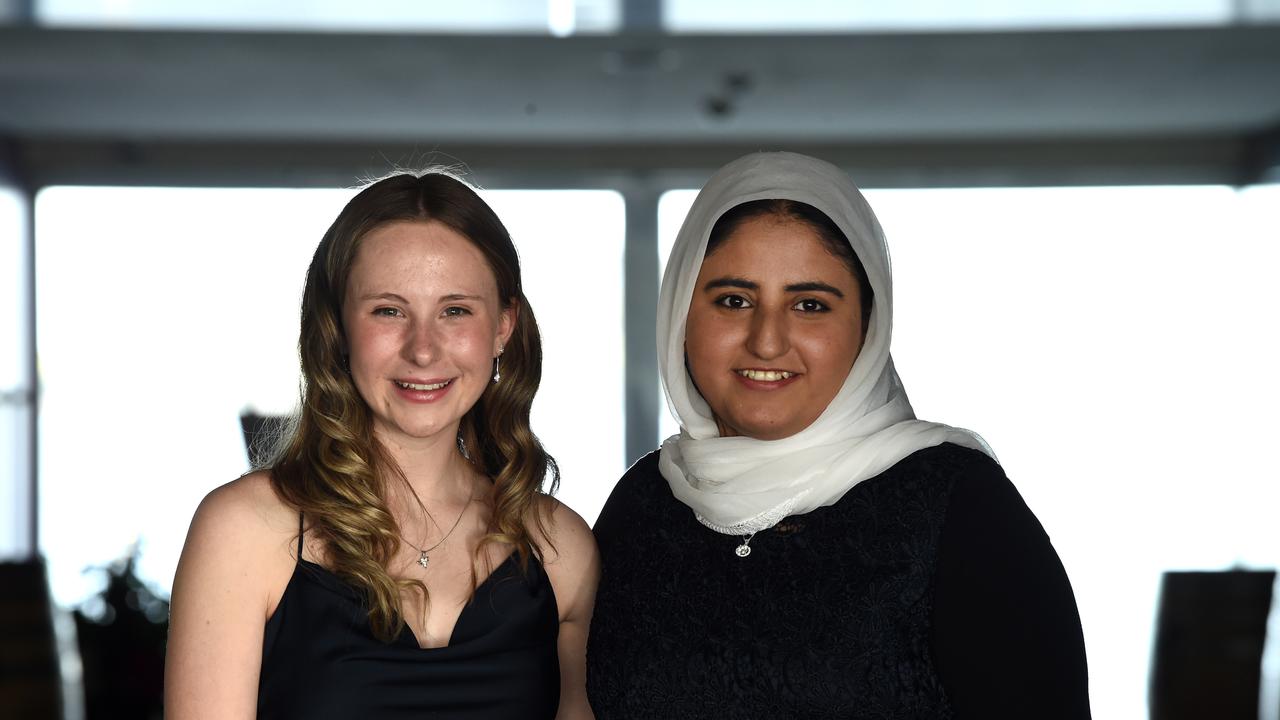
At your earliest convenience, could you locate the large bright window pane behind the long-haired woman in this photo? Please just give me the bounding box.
[36,181,623,605]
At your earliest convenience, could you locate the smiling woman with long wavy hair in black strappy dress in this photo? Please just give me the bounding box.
[165,173,598,720]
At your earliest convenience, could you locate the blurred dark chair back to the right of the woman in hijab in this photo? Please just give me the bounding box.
[1151,570,1276,720]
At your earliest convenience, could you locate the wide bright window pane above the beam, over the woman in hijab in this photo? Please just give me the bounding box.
[663,0,1236,32]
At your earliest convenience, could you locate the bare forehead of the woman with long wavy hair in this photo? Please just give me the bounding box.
[348,220,497,295]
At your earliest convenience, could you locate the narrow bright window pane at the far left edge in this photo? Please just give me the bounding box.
[0,187,33,560]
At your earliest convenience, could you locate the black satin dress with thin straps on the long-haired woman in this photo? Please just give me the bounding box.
[257,515,559,720]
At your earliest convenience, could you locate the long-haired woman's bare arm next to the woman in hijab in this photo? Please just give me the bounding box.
[543,501,600,720]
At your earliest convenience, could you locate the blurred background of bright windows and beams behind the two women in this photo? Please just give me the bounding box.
[0,0,1280,720]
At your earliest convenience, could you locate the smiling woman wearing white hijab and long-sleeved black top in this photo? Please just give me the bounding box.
[588,152,1089,720]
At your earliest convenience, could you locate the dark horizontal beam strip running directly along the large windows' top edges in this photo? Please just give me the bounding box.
[7,136,1249,188]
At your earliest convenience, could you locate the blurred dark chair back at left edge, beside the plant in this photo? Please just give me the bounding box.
[0,560,63,720]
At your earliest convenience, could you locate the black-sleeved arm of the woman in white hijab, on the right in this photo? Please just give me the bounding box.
[933,461,1089,720]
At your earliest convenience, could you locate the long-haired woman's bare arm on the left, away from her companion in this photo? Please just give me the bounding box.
[164,473,297,720]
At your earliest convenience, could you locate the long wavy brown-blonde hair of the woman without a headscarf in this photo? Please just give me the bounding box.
[266,172,559,642]
